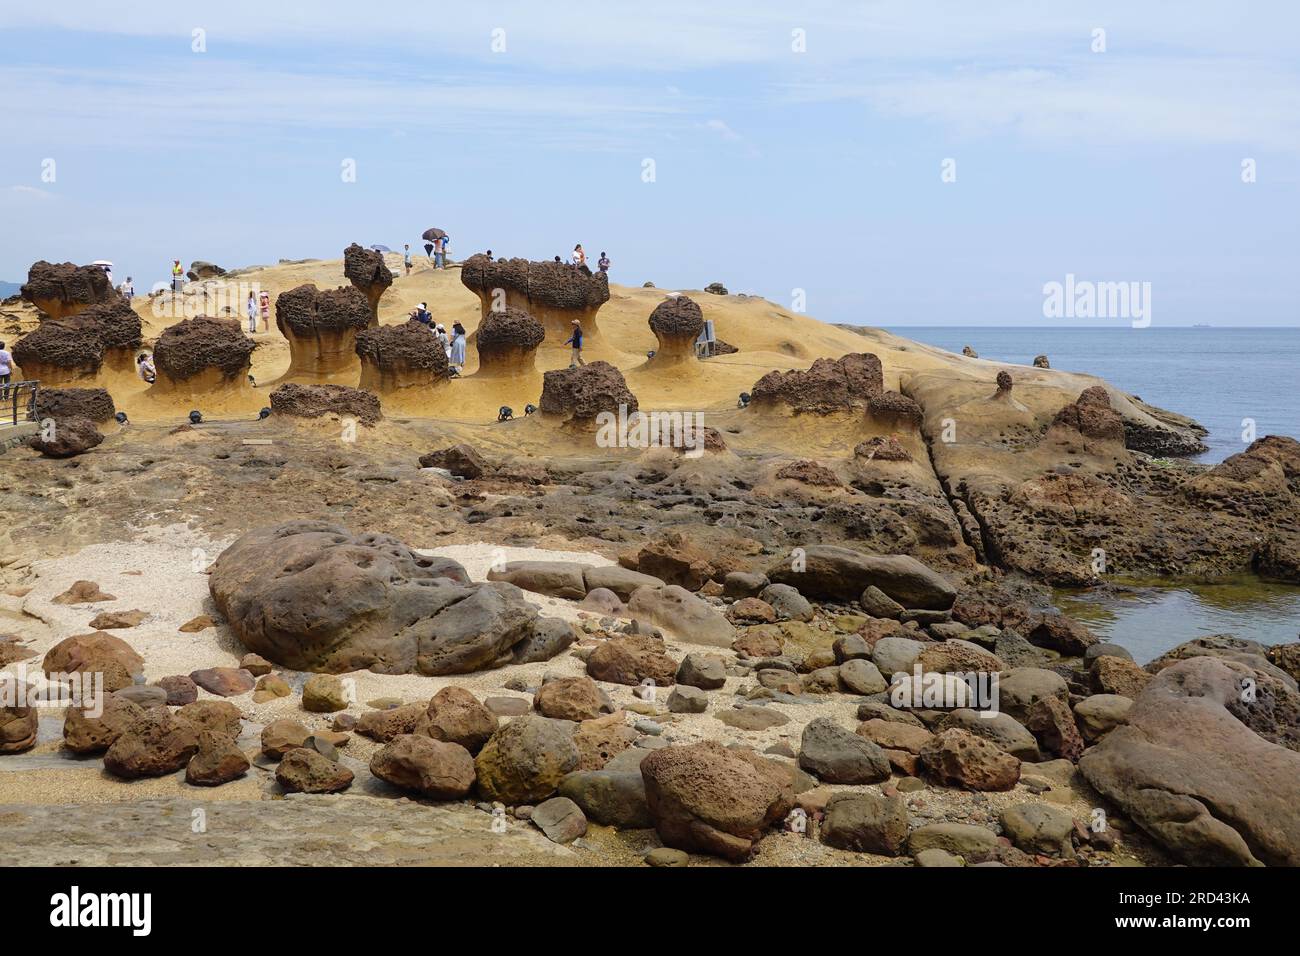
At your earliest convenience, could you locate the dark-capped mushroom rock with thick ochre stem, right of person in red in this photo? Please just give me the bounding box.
[276,284,371,382]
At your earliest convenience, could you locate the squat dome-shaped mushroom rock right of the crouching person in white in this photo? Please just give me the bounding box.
[150,316,255,395]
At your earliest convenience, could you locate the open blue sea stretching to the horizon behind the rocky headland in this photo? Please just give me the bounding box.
[889,325,1300,462]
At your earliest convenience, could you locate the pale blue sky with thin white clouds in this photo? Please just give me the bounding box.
[0,0,1300,328]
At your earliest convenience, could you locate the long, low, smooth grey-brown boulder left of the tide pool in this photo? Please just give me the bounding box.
[767,545,957,610]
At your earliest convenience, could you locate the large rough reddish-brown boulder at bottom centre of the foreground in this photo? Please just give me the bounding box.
[641,741,794,861]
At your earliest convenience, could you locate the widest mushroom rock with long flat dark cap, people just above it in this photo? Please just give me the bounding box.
[460,254,610,347]
